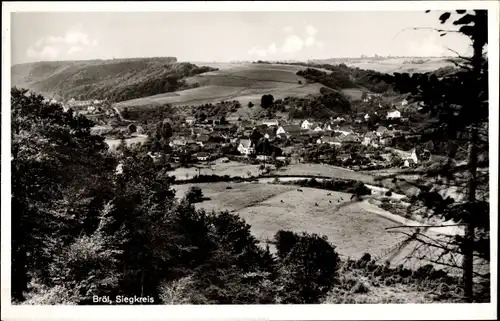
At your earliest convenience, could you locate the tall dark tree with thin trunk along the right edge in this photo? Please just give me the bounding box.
[374,10,489,302]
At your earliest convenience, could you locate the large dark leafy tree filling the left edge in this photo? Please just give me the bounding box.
[11,88,116,302]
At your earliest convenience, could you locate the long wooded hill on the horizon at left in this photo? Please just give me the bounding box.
[11,57,216,101]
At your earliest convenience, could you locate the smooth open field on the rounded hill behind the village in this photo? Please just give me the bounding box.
[115,64,322,107]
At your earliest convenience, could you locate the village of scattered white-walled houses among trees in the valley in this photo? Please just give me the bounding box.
[52,94,442,174]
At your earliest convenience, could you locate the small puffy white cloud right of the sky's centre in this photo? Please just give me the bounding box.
[248,25,325,57]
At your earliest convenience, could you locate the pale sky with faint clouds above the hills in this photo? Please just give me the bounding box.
[11,11,471,65]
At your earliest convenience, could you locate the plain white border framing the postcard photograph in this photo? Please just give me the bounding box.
[1,1,500,320]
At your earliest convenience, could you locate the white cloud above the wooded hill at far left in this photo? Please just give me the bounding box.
[26,25,98,60]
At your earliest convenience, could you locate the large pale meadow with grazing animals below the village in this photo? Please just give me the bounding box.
[174,183,402,259]
